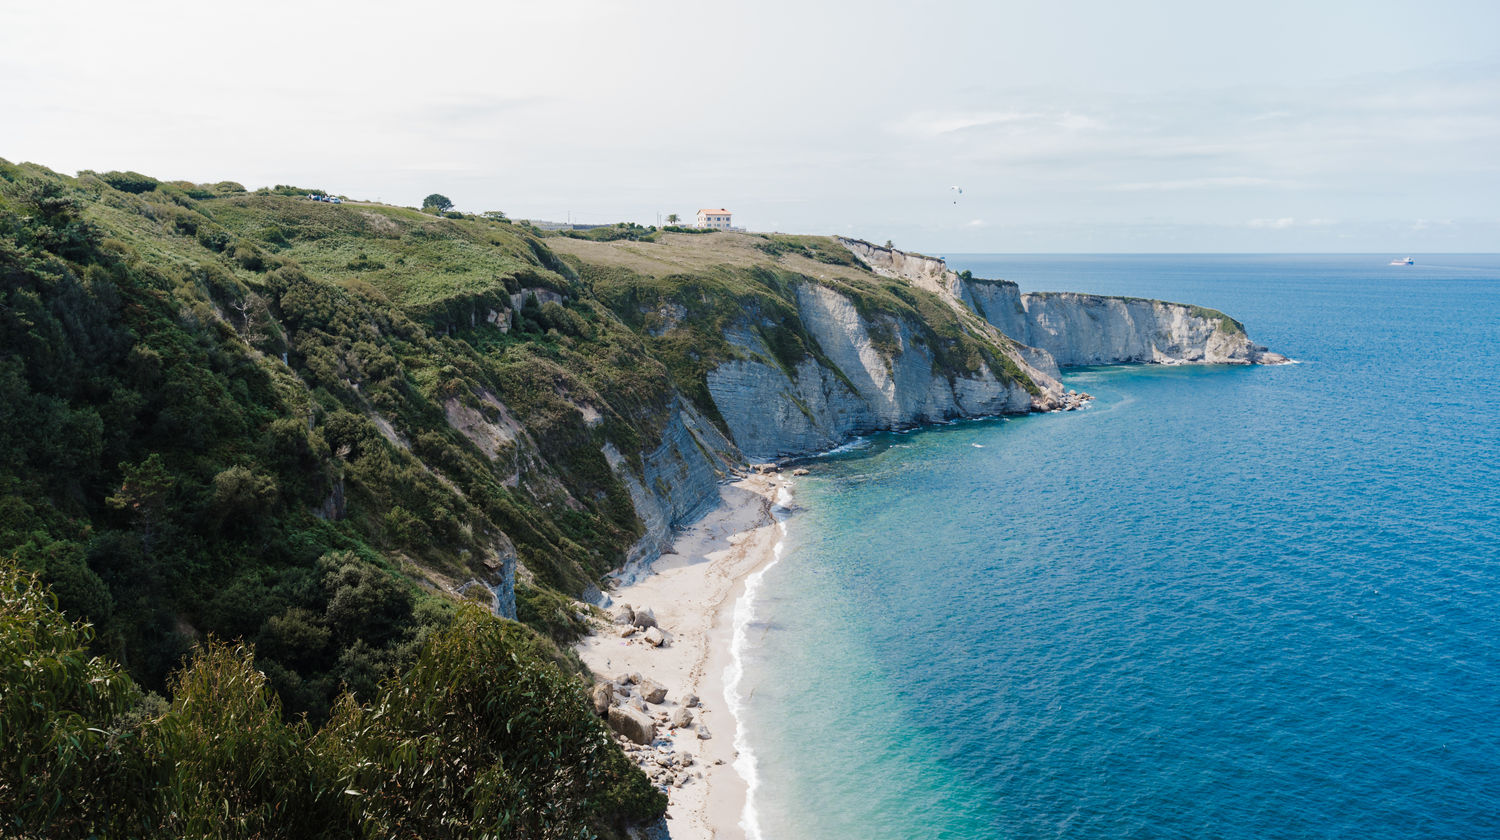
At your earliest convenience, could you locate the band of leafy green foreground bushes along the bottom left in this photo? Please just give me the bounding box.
[0,560,666,840]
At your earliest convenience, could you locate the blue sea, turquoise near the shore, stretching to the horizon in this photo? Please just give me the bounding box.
[743,255,1500,840]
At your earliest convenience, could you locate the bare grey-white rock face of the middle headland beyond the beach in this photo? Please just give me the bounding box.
[708,284,1034,461]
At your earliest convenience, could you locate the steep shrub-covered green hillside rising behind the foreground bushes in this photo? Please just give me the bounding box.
[0,164,690,716]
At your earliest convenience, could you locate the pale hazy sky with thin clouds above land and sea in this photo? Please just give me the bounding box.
[0,0,1500,255]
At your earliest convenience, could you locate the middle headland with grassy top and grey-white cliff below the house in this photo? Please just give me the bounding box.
[549,234,1067,461]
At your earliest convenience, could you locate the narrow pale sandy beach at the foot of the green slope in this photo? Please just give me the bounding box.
[578,476,791,840]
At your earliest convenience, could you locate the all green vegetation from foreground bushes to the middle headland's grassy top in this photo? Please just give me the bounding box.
[0,161,1044,836]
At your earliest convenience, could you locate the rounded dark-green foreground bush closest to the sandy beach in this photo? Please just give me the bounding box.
[314,605,666,839]
